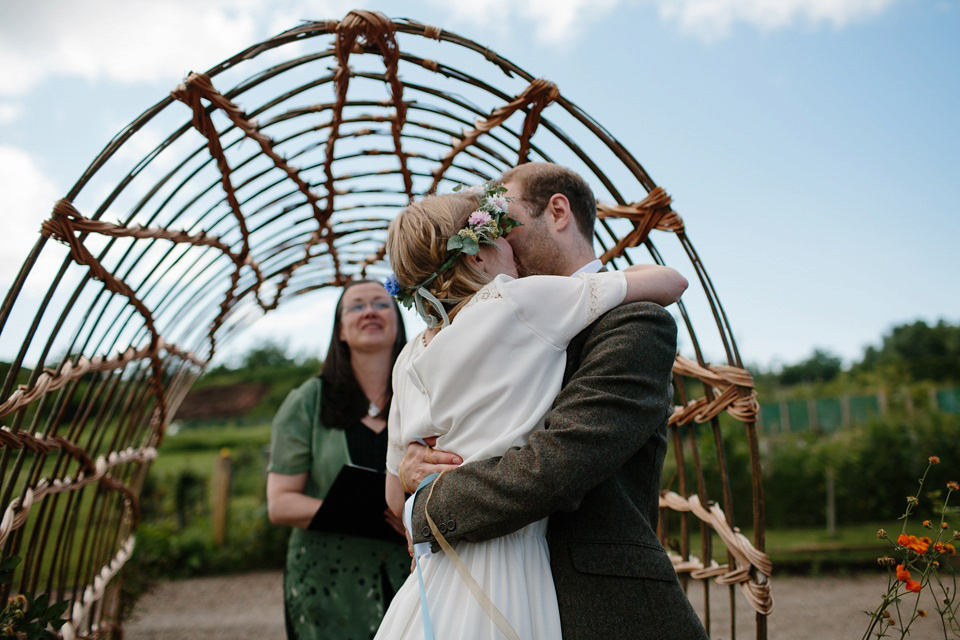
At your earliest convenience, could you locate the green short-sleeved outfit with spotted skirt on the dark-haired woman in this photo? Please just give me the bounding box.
[268,378,410,640]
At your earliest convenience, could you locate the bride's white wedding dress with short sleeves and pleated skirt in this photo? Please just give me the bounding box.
[376,271,626,640]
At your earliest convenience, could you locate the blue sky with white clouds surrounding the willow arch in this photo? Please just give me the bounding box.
[0,0,960,366]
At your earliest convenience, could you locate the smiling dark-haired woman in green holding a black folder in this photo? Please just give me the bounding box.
[267,281,410,640]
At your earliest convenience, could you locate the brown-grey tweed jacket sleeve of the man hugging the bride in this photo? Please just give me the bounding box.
[412,302,677,542]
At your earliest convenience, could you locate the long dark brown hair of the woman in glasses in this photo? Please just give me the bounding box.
[320,280,407,429]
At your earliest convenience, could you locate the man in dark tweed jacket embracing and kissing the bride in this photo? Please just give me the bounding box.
[400,163,706,640]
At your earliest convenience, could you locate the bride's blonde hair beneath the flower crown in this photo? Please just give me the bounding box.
[387,193,492,322]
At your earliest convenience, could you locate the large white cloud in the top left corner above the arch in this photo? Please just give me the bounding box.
[0,0,341,96]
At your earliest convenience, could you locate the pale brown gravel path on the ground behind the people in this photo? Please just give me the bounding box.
[124,572,943,640]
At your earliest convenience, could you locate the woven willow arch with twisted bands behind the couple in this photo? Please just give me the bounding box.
[0,11,772,638]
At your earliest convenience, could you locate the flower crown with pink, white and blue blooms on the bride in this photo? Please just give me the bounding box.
[384,180,521,328]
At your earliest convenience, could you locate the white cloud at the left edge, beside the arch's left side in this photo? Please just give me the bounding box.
[0,145,60,288]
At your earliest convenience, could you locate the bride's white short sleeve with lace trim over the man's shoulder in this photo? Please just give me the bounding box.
[495,271,627,349]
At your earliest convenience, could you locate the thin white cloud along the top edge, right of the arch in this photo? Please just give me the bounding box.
[652,0,897,40]
